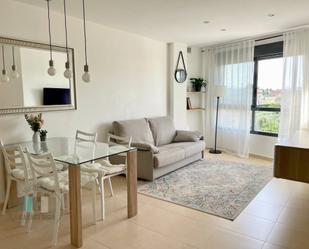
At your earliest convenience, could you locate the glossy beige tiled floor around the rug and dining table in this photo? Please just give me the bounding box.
[0,154,309,249]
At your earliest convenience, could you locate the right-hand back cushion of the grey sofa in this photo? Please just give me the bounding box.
[148,117,176,146]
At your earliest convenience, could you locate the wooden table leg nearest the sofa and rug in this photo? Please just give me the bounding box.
[127,150,137,218]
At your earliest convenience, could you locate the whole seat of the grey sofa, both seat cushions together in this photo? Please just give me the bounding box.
[154,140,205,168]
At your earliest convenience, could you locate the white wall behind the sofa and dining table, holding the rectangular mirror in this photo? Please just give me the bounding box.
[0,0,167,202]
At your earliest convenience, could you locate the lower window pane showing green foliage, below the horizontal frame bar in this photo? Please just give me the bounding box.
[254,111,280,134]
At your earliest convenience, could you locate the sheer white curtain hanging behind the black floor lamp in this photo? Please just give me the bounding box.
[203,40,254,157]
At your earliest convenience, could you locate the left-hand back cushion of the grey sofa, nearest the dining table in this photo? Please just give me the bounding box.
[113,118,154,144]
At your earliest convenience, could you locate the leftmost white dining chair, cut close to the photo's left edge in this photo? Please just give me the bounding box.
[0,140,34,230]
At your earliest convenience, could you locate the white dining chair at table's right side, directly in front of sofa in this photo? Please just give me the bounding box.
[82,134,132,220]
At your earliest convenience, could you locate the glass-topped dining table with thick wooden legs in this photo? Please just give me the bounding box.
[13,137,137,248]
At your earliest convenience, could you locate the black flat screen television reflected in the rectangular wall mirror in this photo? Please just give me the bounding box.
[43,88,71,105]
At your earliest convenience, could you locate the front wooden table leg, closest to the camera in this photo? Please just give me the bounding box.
[69,165,83,248]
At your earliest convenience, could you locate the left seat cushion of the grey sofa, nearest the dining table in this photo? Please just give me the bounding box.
[154,145,185,168]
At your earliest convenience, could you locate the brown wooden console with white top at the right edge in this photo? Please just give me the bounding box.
[274,131,309,183]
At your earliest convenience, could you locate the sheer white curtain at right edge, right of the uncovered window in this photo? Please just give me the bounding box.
[279,29,309,141]
